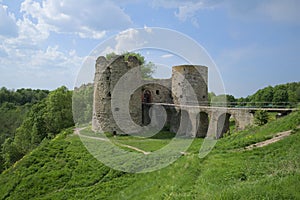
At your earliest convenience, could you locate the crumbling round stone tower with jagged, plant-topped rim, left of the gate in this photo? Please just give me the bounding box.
[92,56,142,134]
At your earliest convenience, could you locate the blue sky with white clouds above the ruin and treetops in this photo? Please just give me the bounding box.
[0,0,300,97]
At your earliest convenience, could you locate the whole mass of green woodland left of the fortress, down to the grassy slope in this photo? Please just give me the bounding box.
[0,86,74,172]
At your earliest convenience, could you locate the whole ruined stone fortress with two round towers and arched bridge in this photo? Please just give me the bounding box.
[92,55,270,138]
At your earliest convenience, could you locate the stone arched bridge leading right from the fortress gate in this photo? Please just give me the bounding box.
[143,103,296,138]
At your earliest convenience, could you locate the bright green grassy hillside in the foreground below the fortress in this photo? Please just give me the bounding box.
[0,112,300,199]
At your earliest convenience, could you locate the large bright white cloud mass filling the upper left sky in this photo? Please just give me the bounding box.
[0,0,132,89]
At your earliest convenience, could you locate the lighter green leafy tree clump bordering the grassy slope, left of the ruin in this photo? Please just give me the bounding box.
[14,86,74,155]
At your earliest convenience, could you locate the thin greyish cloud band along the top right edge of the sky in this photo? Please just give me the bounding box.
[151,0,300,27]
